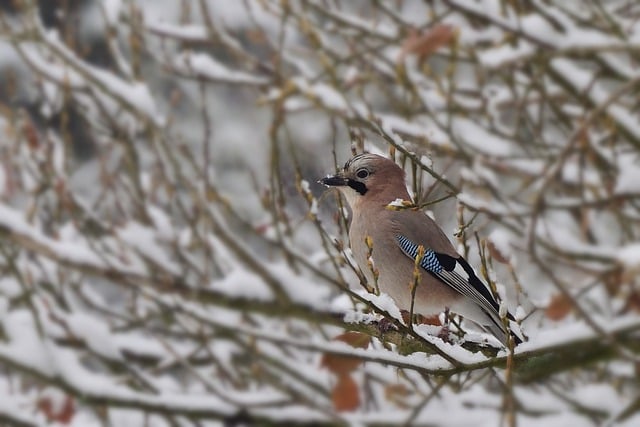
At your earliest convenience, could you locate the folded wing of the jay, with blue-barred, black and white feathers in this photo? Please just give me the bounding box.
[393,211,502,328]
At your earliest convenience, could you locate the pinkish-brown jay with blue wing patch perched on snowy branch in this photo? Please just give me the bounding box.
[319,153,522,344]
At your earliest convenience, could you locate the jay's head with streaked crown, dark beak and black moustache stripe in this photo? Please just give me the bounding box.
[319,153,410,208]
